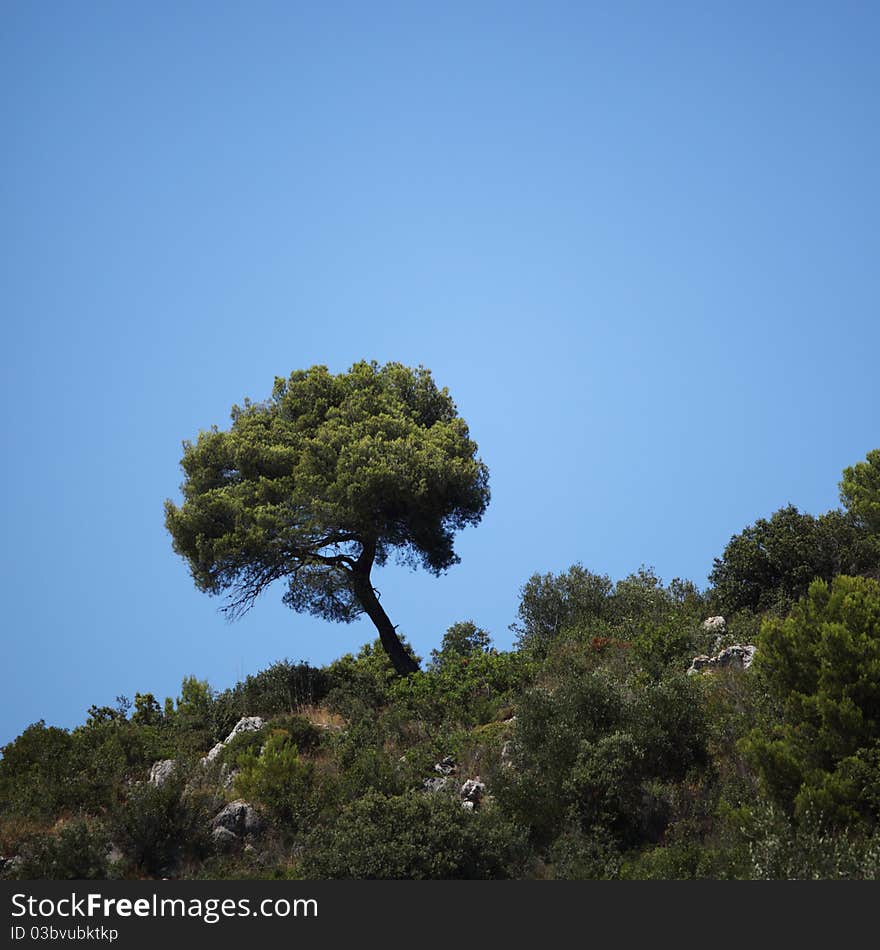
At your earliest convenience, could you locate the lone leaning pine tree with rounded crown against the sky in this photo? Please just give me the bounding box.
[165,362,489,674]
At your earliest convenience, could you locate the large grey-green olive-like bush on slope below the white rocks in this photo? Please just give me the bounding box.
[496,652,707,863]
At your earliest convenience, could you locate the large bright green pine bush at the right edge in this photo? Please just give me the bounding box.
[746,576,880,824]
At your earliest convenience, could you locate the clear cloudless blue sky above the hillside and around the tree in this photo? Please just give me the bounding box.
[0,0,880,742]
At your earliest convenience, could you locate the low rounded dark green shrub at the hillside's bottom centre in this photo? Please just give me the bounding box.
[303,791,527,880]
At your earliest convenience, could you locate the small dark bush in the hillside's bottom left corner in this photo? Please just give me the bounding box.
[15,819,110,881]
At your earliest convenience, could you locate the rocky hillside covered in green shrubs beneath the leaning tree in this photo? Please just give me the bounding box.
[0,451,880,879]
